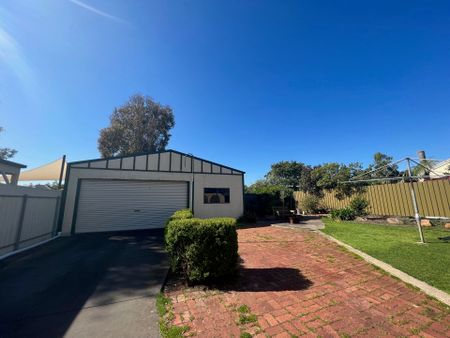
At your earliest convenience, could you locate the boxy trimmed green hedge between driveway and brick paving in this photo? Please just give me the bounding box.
[165,214,238,283]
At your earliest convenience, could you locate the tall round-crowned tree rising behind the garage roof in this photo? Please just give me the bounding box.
[98,94,175,157]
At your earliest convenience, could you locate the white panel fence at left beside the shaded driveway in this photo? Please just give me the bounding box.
[0,184,61,257]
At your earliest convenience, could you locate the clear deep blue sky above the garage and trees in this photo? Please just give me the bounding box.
[0,0,450,183]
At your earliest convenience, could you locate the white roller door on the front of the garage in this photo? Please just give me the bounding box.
[75,180,188,233]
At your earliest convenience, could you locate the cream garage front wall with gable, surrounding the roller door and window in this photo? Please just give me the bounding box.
[61,151,244,235]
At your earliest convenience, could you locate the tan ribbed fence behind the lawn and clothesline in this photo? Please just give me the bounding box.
[294,179,450,217]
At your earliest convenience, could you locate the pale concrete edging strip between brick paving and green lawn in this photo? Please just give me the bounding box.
[317,230,450,306]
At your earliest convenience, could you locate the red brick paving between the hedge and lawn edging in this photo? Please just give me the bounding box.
[166,227,450,337]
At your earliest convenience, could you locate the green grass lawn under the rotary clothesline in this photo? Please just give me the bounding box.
[322,219,450,293]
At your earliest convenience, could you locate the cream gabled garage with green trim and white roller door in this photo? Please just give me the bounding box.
[61,150,244,235]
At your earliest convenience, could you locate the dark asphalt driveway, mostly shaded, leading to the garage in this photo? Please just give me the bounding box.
[0,230,168,338]
